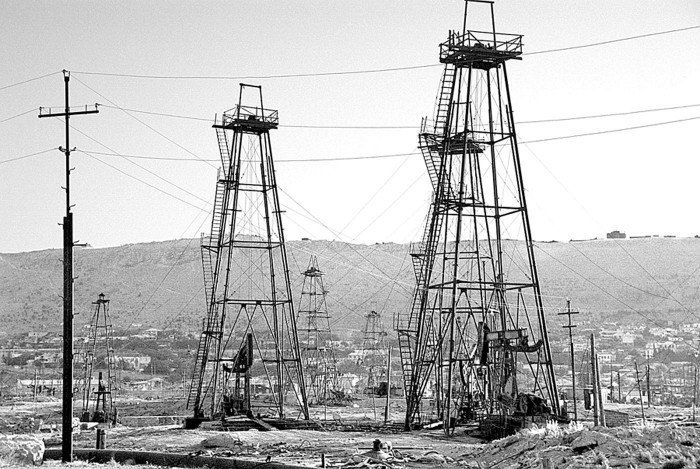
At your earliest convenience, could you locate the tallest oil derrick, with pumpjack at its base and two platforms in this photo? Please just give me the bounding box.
[395,0,559,432]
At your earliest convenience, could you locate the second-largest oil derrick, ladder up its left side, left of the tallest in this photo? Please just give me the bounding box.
[187,84,309,425]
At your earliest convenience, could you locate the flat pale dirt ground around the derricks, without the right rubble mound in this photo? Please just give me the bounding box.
[0,399,691,468]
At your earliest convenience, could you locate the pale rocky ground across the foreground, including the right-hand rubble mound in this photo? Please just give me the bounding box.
[0,394,700,469]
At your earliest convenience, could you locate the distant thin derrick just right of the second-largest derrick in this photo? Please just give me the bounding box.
[297,256,338,404]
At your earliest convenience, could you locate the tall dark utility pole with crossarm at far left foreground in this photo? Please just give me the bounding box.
[39,70,99,462]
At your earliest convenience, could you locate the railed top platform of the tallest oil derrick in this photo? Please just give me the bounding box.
[440,31,523,70]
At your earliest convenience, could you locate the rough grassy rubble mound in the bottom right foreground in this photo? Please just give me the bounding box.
[458,423,700,469]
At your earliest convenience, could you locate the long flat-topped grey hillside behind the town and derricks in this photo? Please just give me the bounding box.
[0,238,700,334]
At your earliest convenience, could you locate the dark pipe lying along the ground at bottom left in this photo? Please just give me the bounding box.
[44,449,309,469]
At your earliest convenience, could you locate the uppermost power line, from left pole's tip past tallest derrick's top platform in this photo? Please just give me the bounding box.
[68,25,700,80]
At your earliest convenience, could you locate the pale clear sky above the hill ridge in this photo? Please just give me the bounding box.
[0,0,700,253]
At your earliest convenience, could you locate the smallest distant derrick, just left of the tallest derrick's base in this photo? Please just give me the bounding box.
[361,310,388,394]
